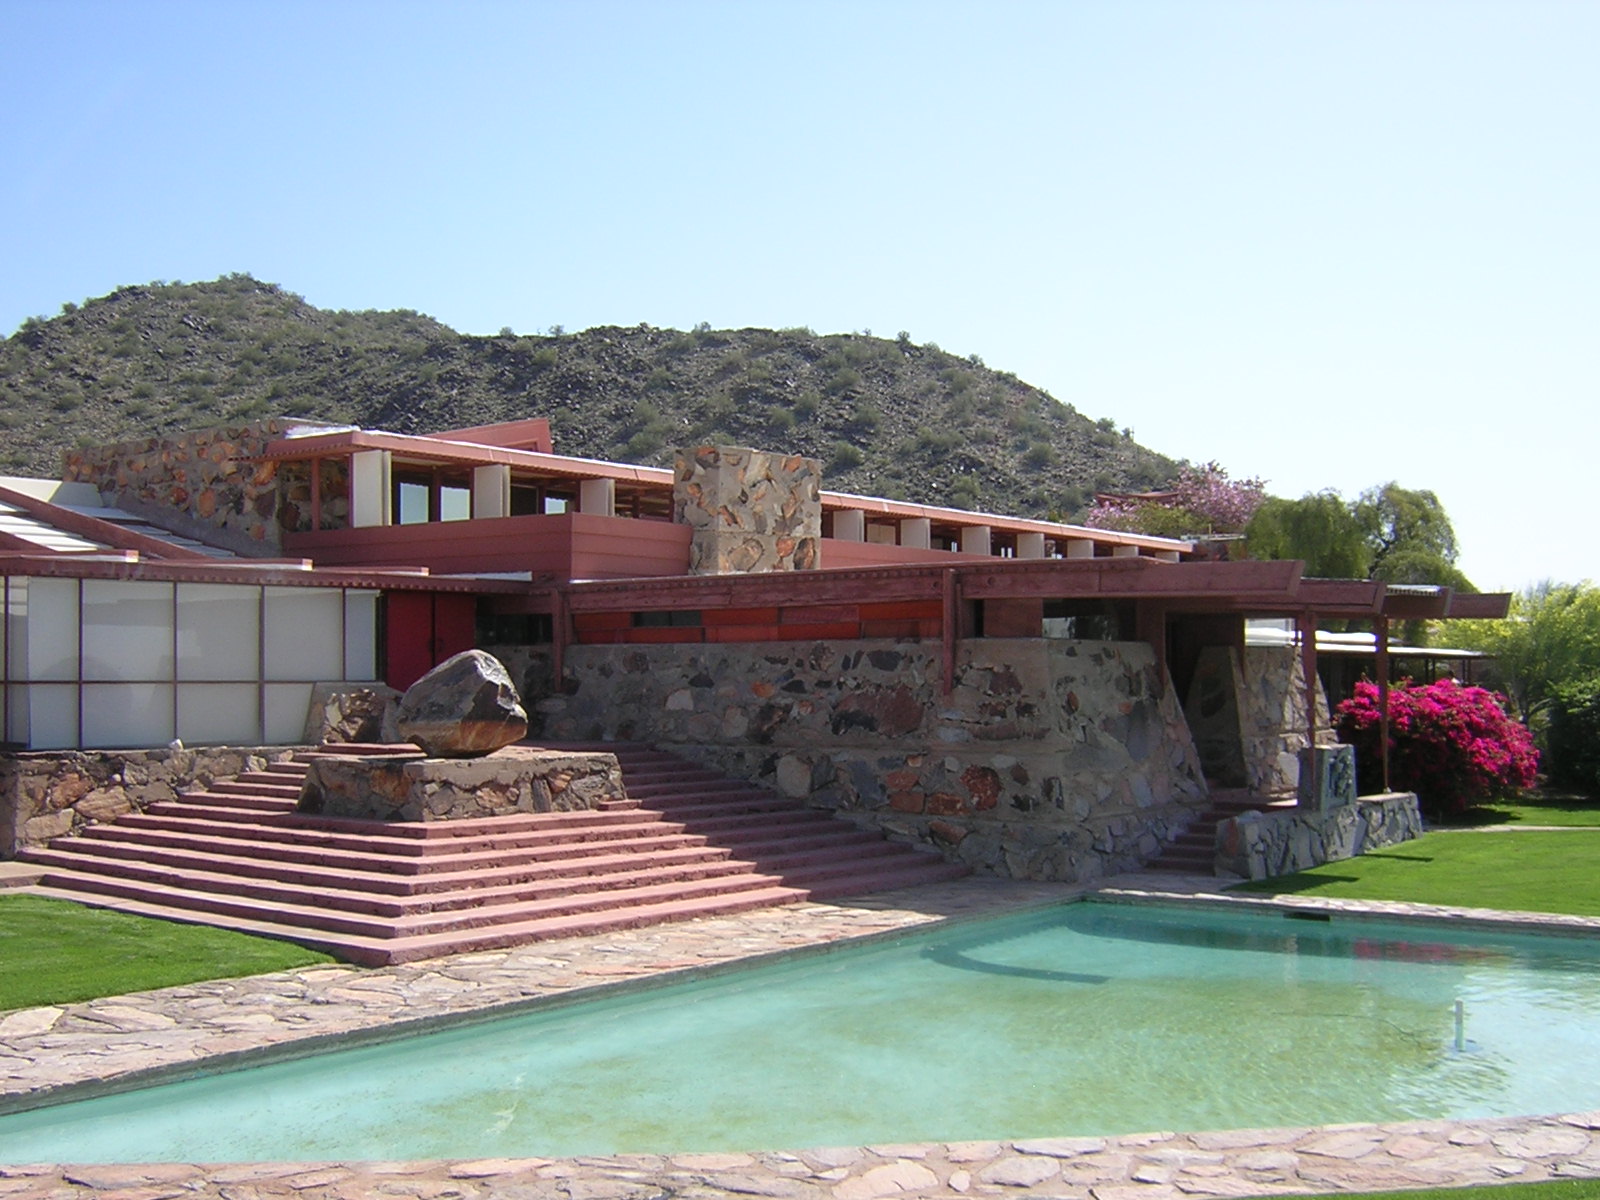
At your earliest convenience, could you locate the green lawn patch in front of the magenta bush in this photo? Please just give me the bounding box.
[1234,829,1600,917]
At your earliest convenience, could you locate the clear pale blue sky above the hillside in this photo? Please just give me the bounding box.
[0,0,1600,589]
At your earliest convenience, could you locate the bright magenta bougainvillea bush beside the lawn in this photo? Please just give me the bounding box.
[1338,678,1539,814]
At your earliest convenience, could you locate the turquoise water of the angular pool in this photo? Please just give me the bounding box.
[0,902,1600,1163]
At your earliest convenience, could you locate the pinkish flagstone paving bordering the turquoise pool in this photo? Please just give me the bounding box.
[0,874,1600,1200]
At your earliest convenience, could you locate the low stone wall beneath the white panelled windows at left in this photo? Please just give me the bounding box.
[0,746,294,858]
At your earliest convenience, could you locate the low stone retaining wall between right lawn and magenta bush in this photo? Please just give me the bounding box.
[1216,792,1422,878]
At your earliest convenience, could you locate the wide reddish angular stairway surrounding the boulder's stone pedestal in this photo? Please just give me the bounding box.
[21,744,966,965]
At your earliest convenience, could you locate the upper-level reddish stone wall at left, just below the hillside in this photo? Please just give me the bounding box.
[62,418,347,557]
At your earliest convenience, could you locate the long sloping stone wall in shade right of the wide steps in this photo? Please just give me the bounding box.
[531,638,1206,880]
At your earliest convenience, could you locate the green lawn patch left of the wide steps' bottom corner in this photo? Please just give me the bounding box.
[0,894,334,1011]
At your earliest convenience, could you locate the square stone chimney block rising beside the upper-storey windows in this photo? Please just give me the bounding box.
[672,446,822,574]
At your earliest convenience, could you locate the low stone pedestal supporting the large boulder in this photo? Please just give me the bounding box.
[299,746,627,821]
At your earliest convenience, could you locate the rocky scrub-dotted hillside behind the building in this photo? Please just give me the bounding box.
[0,275,1176,517]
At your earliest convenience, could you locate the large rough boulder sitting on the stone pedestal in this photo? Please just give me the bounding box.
[395,650,528,758]
